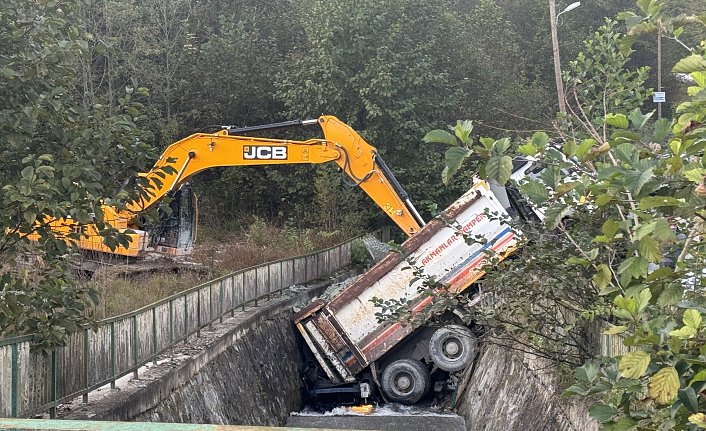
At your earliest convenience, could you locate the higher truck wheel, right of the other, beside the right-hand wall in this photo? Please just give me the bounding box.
[429,325,478,372]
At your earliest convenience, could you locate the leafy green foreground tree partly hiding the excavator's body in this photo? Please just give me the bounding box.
[0,0,153,346]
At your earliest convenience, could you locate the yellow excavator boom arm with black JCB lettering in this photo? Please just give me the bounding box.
[128,116,424,236]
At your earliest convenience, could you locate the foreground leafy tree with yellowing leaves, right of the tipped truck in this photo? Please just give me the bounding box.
[428,1,706,430]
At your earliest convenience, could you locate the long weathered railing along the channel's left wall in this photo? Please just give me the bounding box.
[0,240,354,417]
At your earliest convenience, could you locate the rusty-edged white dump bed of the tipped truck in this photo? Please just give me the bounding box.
[293,182,516,383]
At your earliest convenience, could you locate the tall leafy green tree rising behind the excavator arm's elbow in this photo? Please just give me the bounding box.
[277,0,462,219]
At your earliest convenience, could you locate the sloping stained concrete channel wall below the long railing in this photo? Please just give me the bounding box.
[60,283,340,426]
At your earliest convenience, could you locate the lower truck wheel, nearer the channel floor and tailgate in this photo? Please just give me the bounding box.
[380,359,431,404]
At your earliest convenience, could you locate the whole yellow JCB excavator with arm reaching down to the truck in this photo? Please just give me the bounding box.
[51,115,424,257]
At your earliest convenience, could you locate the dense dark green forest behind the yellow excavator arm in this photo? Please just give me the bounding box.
[67,0,689,236]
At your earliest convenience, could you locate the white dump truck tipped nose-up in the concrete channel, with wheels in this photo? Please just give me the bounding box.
[293,181,518,404]
